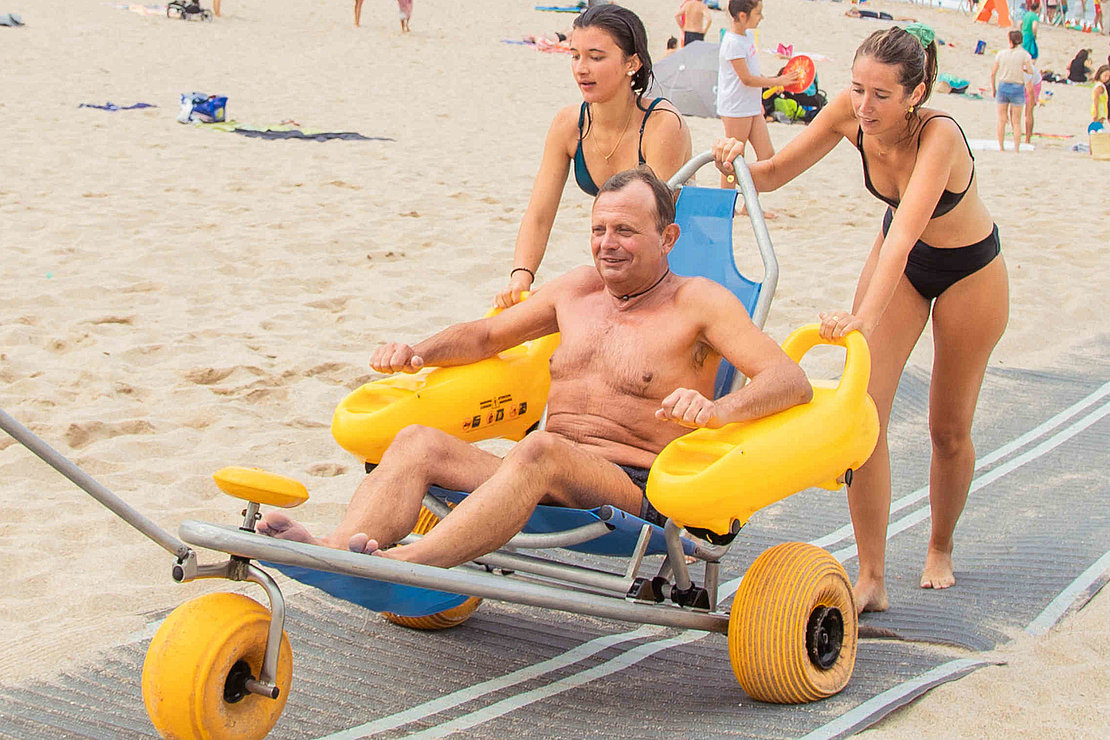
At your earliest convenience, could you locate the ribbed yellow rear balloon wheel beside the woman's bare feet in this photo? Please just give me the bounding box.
[728,543,858,703]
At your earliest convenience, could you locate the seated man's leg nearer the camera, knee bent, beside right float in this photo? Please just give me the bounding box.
[381,432,643,567]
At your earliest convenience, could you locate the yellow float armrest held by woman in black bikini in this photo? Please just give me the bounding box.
[647,324,879,535]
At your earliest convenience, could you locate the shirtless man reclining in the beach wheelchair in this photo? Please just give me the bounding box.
[259,166,813,567]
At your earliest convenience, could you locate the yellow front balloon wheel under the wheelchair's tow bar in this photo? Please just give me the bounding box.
[142,594,293,740]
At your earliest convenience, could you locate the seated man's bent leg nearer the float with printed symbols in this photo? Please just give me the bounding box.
[259,426,502,550]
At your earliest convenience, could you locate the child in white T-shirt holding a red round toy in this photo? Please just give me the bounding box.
[717,0,800,190]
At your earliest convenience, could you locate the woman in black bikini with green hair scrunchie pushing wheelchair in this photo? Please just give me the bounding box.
[714,23,1009,611]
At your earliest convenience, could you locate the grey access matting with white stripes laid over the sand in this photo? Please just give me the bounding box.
[0,339,1110,739]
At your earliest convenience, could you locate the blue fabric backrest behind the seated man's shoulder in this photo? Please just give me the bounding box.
[669,185,763,398]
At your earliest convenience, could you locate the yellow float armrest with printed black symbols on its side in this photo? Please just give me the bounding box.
[332,295,558,464]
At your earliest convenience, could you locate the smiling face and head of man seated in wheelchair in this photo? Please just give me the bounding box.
[589,182,677,283]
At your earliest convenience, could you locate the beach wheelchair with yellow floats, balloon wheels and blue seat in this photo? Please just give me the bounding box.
[0,152,878,738]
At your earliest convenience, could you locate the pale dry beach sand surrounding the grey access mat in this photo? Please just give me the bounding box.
[0,0,1110,737]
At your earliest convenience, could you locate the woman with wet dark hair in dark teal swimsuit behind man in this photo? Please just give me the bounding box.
[495,6,692,307]
